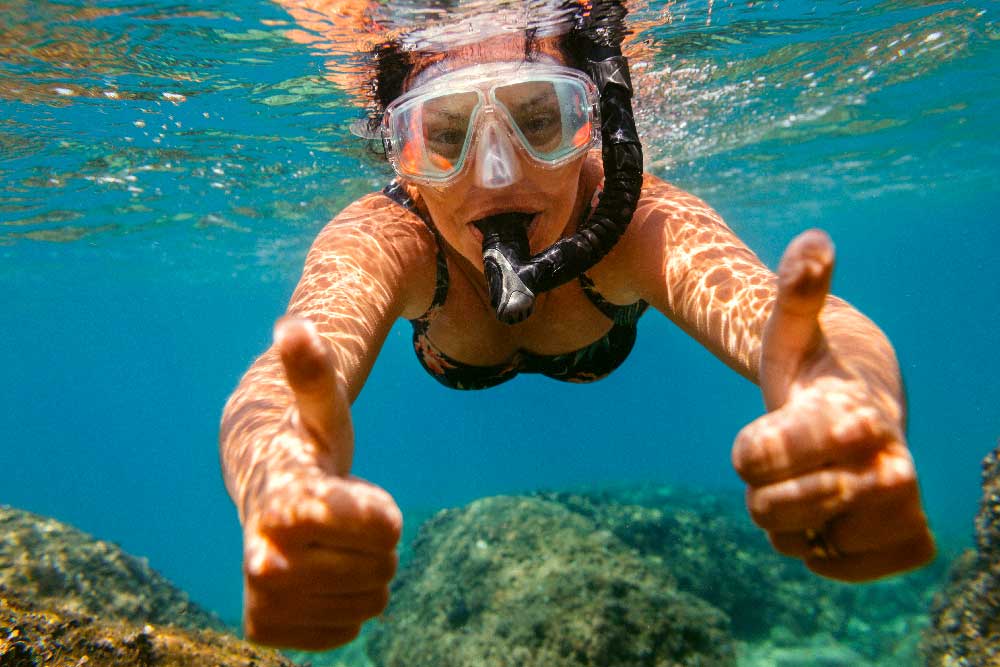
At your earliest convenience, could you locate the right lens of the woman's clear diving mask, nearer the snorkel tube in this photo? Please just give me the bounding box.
[494,78,592,161]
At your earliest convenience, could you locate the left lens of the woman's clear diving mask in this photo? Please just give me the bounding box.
[391,92,479,178]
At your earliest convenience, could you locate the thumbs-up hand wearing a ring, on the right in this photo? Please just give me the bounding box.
[733,230,934,581]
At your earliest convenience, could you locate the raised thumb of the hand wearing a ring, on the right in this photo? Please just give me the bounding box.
[760,229,834,410]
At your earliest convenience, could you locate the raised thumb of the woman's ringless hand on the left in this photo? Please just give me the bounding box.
[274,317,354,477]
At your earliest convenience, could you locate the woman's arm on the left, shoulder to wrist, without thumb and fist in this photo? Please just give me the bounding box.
[220,196,435,518]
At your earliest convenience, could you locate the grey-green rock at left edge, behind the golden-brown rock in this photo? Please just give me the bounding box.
[0,506,226,631]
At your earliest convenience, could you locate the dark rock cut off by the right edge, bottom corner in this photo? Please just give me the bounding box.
[921,445,1000,667]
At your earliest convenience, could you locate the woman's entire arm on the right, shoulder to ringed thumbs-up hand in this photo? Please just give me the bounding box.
[629,179,934,581]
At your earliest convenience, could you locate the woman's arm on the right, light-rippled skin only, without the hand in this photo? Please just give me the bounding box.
[632,177,903,408]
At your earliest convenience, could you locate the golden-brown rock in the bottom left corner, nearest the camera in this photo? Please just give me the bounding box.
[0,587,294,667]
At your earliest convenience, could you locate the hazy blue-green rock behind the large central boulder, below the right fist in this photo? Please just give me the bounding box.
[541,485,944,660]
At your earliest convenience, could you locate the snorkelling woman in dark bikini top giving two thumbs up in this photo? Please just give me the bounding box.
[221,5,934,649]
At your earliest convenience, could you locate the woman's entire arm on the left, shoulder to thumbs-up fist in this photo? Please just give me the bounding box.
[220,190,434,648]
